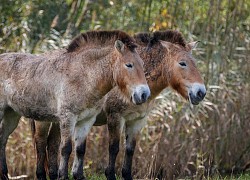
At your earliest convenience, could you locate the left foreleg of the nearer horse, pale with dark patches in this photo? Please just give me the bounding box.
[58,113,76,179]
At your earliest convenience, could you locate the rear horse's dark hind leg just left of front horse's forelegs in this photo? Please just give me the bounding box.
[47,123,61,180]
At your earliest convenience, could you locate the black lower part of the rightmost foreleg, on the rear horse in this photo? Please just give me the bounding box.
[122,135,136,180]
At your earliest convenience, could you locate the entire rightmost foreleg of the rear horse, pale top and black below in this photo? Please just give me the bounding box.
[122,119,146,180]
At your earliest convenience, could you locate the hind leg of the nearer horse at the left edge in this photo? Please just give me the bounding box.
[0,107,20,180]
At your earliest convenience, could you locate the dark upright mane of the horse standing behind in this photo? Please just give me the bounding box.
[134,30,186,48]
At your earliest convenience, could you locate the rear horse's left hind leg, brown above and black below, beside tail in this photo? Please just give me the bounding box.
[33,121,50,180]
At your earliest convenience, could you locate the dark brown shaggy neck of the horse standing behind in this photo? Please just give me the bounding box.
[138,45,169,99]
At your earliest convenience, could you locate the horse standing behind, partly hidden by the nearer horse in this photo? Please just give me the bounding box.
[31,30,206,180]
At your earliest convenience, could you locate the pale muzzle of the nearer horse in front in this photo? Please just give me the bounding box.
[131,85,150,105]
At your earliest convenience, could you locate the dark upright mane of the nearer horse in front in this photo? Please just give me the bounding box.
[67,30,137,52]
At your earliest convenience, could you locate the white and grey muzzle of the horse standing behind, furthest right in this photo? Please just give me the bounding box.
[188,83,206,105]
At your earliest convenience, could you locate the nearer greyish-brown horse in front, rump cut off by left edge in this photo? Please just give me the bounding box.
[0,31,150,179]
